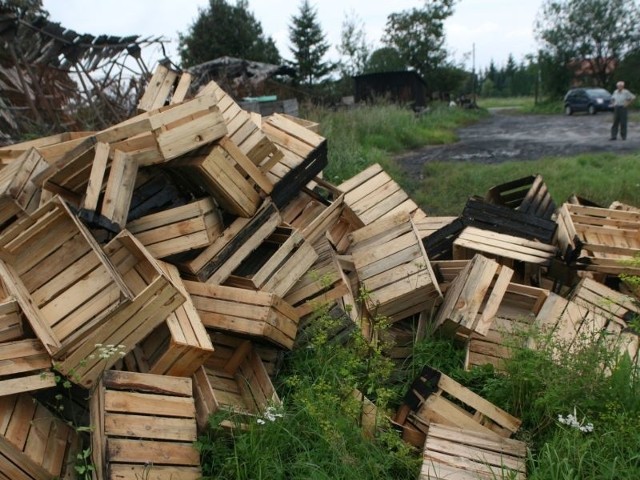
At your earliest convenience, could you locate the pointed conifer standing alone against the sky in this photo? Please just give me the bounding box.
[289,0,334,86]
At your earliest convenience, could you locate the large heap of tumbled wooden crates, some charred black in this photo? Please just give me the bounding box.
[0,67,640,479]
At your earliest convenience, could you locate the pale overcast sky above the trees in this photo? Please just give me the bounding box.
[43,0,542,70]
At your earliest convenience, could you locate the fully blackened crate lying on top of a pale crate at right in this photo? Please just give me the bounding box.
[462,196,556,244]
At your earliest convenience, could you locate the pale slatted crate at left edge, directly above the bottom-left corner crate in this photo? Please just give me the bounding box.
[0,338,56,396]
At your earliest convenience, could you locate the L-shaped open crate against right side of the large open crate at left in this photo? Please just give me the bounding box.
[54,230,186,387]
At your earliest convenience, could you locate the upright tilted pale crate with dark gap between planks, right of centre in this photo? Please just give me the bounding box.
[435,254,513,340]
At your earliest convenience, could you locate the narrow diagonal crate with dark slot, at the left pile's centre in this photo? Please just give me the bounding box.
[179,202,282,284]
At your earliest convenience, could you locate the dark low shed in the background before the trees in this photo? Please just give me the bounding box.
[353,70,427,108]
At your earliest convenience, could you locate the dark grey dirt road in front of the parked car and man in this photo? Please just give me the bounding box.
[396,109,640,175]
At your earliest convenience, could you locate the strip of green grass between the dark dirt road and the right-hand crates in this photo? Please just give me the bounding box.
[412,153,640,215]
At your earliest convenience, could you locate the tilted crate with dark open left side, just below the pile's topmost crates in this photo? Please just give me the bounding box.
[169,137,273,217]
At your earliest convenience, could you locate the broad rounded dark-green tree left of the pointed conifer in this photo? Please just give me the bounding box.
[178,0,281,67]
